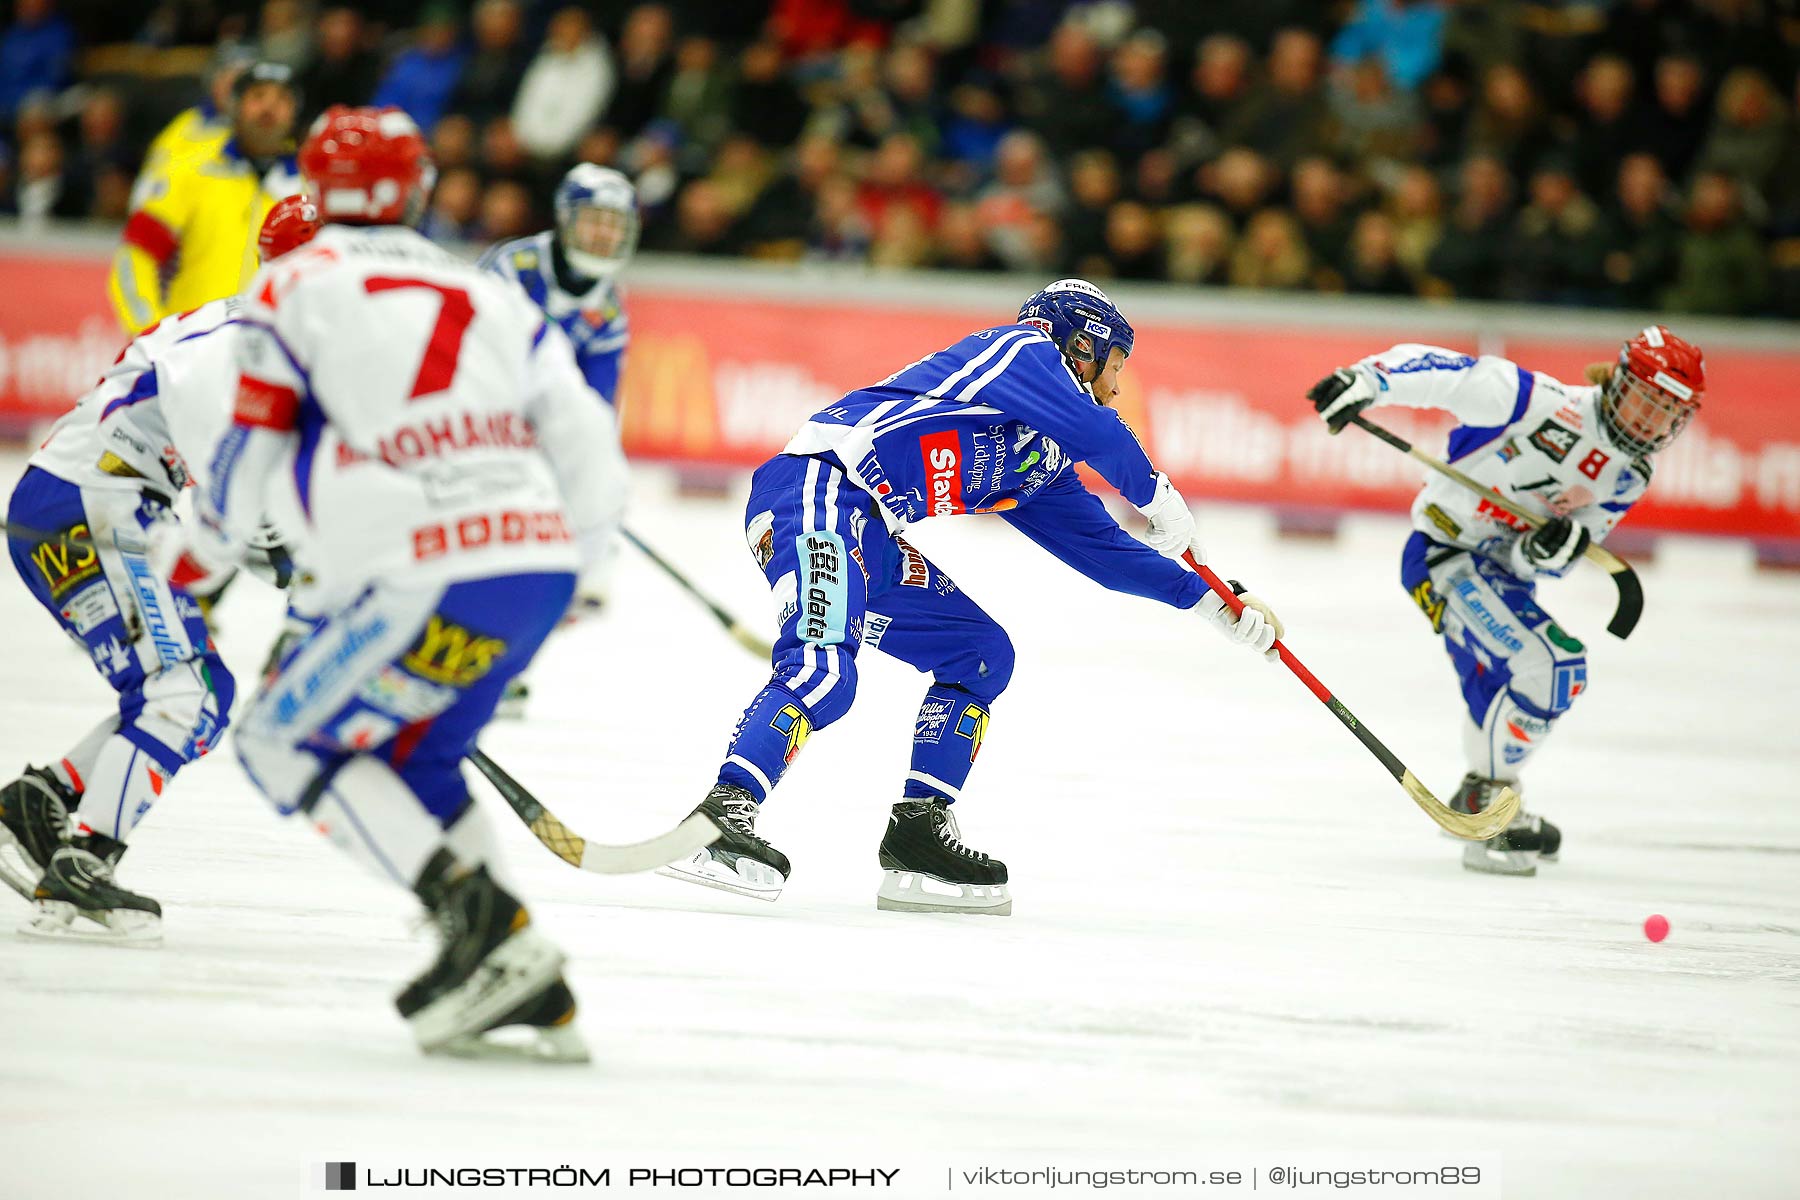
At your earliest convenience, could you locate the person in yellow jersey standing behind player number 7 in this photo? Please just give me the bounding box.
[106,63,301,335]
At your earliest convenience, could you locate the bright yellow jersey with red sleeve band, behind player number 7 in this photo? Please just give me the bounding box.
[106,139,301,335]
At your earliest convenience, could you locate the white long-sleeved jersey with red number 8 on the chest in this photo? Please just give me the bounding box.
[1357,344,1651,574]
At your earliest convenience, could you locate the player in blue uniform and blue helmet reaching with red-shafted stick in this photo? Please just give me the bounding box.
[664,279,1282,916]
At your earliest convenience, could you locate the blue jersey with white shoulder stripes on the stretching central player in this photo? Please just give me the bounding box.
[787,326,1206,608]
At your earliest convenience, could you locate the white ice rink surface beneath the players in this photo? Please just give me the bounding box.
[0,459,1800,1200]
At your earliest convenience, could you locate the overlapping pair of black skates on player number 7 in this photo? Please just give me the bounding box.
[394,851,587,1063]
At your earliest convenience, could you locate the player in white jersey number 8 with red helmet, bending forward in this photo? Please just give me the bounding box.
[1309,326,1706,874]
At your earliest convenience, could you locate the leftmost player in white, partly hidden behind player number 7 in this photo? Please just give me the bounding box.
[0,196,317,943]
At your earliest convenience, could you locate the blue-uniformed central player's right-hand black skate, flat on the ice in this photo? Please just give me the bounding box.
[875,799,1012,918]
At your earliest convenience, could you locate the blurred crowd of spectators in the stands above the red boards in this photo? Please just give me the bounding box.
[0,0,1800,318]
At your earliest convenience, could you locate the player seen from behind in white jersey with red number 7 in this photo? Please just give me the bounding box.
[158,106,625,1060]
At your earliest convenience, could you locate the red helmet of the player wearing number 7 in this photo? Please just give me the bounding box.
[299,104,437,225]
